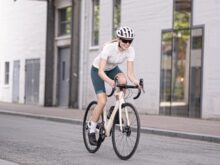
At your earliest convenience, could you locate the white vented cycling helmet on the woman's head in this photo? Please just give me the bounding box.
[116,26,135,40]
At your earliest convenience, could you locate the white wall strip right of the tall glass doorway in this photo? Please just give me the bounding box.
[193,0,220,118]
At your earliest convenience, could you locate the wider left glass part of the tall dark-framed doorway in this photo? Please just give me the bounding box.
[160,30,190,116]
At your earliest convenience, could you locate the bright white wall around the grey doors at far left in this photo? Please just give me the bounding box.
[0,0,46,104]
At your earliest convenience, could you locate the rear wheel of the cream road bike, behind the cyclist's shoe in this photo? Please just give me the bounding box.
[83,101,101,153]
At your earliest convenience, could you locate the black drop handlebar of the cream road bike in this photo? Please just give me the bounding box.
[107,79,145,99]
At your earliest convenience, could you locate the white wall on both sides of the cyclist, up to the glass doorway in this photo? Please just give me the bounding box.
[83,0,173,114]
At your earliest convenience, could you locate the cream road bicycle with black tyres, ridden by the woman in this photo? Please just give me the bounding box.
[83,79,144,160]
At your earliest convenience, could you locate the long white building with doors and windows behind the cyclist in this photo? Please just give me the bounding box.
[0,0,220,118]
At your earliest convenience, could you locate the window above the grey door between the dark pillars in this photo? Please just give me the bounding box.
[58,7,72,35]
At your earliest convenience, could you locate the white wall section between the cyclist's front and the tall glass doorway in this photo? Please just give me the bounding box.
[122,0,173,114]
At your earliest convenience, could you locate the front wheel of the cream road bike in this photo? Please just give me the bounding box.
[112,103,140,160]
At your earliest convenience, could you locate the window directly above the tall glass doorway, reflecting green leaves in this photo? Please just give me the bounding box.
[174,0,192,29]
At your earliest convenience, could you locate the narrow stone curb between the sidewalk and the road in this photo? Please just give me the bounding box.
[0,110,220,143]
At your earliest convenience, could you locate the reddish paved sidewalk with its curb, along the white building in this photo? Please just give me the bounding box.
[0,102,220,143]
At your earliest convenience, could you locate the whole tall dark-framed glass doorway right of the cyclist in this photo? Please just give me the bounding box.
[160,28,203,117]
